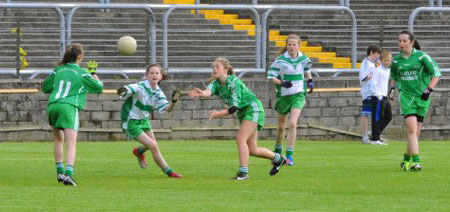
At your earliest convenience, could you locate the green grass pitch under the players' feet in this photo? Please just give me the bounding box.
[0,141,450,212]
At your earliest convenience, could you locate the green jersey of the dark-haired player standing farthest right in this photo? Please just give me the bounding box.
[391,49,441,96]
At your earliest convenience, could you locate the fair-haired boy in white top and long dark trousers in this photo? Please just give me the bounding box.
[370,51,392,145]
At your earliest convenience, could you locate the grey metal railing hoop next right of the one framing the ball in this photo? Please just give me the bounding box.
[162,5,261,69]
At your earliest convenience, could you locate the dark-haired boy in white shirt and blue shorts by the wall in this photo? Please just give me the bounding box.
[359,44,381,144]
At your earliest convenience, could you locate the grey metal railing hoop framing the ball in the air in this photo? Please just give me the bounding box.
[66,4,156,63]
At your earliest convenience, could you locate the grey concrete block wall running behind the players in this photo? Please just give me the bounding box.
[0,78,450,141]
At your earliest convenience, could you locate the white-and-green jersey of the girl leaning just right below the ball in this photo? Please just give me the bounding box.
[120,80,169,129]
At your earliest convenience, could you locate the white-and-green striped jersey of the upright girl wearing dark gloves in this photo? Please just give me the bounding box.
[267,51,312,97]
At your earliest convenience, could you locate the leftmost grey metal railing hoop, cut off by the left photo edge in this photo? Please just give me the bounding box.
[0,3,66,57]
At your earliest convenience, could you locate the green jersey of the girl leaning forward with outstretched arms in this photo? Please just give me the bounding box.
[207,75,256,109]
